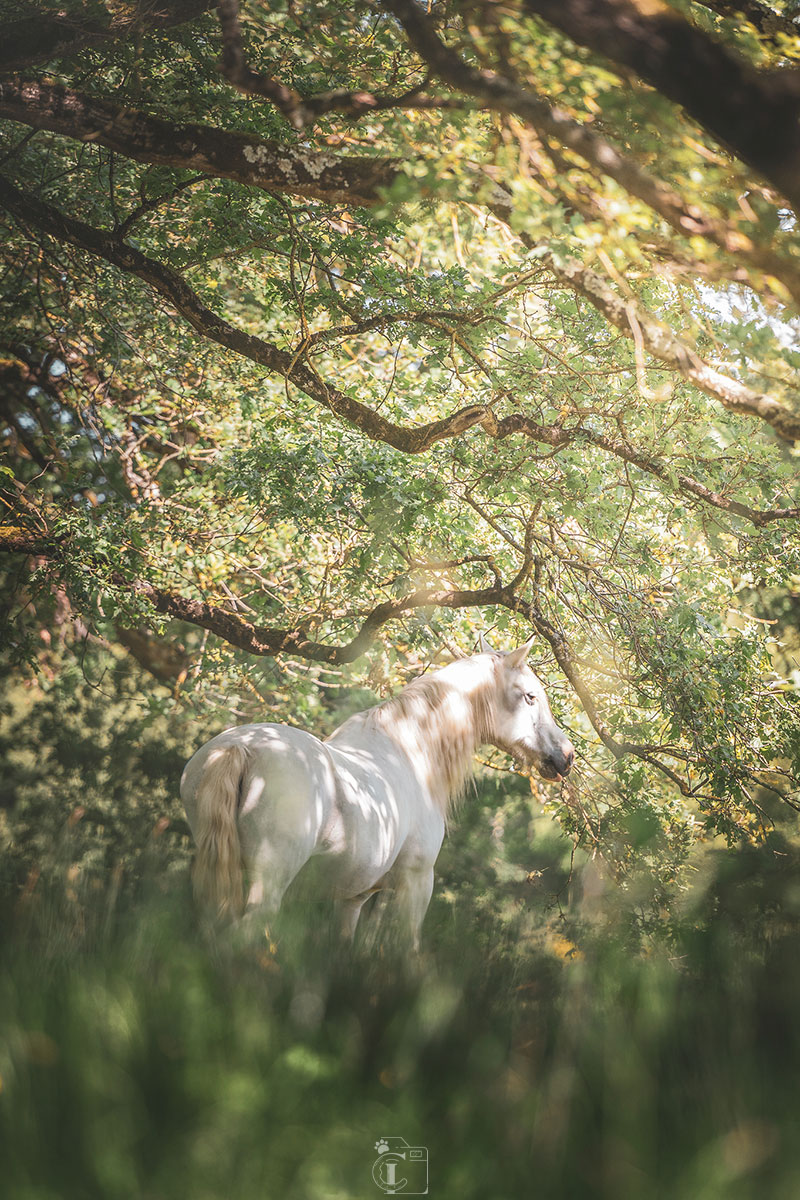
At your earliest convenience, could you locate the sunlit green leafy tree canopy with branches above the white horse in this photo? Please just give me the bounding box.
[0,0,800,882]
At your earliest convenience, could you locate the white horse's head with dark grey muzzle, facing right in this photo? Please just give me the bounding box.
[481,637,575,780]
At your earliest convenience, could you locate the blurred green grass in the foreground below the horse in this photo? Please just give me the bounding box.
[0,834,800,1200]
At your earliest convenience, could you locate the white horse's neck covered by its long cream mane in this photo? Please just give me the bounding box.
[363,655,497,815]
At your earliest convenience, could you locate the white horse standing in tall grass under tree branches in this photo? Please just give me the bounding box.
[181,638,575,948]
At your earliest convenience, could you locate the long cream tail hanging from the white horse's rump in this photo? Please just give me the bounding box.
[192,743,247,916]
